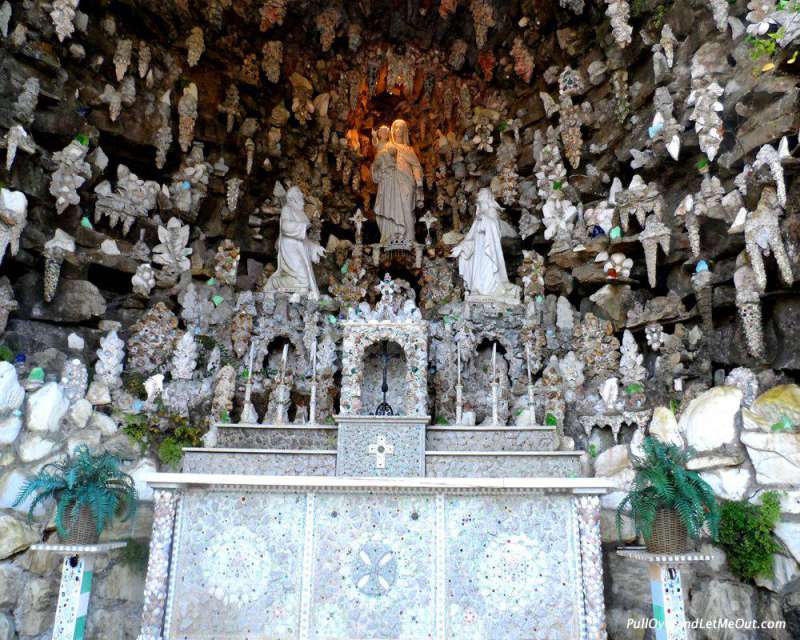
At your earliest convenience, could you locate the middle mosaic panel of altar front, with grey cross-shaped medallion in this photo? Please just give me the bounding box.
[309,494,435,640]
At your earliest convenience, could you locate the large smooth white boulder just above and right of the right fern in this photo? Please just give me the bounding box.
[678,386,742,452]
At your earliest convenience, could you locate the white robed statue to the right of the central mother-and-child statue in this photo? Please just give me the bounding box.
[452,188,519,299]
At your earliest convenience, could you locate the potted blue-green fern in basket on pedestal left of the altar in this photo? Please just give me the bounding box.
[14,445,138,544]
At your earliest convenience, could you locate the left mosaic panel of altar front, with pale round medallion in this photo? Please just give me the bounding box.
[166,490,305,640]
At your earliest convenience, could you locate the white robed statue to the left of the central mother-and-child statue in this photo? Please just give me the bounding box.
[264,187,325,299]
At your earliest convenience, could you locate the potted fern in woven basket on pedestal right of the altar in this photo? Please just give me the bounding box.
[616,436,720,553]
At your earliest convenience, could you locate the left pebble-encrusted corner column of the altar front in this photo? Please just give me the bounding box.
[137,489,178,640]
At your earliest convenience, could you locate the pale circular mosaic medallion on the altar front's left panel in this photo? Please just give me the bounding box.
[202,525,272,607]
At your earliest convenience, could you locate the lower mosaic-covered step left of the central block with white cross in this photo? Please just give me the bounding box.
[183,447,336,476]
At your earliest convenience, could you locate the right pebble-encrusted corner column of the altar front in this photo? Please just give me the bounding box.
[575,496,607,640]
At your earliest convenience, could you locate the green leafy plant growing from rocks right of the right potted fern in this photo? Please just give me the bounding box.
[719,491,781,580]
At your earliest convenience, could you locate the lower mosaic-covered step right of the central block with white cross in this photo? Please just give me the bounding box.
[425,451,585,478]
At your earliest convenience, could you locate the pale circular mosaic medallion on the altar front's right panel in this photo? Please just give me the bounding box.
[477,535,549,610]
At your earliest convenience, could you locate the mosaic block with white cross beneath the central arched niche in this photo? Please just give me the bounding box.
[334,416,430,477]
